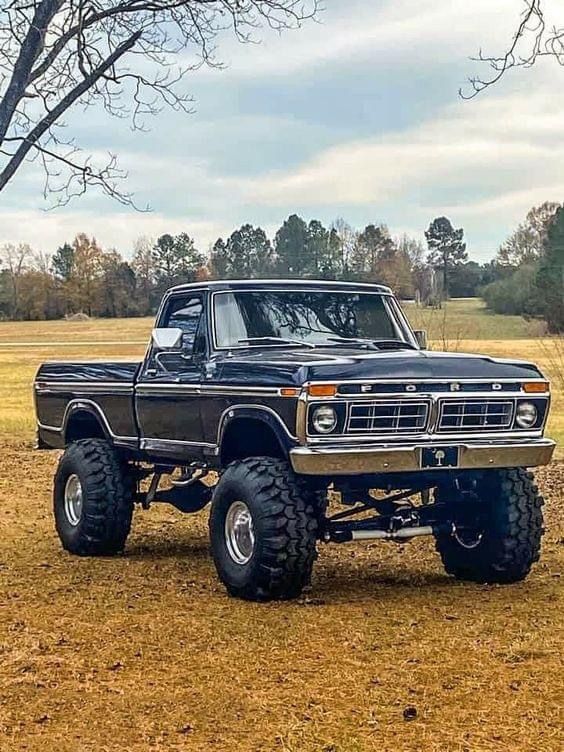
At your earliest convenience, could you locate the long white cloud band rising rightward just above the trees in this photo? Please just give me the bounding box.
[242,88,564,223]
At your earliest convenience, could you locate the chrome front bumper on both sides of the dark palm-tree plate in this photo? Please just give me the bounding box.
[290,438,556,475]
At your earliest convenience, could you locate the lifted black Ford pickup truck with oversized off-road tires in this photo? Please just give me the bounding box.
[35,280,554,600]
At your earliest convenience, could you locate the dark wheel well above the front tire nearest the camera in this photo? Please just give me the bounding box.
[221,418,286,466]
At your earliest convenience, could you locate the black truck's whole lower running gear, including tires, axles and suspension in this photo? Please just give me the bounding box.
[51,439,543,601]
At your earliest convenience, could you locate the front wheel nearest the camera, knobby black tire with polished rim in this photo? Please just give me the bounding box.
[210,457,317,601]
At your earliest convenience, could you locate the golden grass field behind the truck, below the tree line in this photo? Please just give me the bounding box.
[0,299,564,456]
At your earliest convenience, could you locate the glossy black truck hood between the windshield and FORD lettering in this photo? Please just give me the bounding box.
[216,348,542,386]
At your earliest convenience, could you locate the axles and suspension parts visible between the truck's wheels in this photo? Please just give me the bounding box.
[130,463,492,545]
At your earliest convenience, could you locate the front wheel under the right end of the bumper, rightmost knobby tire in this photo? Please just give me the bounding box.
[436,468,544,583]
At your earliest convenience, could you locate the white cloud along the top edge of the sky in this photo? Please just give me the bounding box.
[200,0,521,77]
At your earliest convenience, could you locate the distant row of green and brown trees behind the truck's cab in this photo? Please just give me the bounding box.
[0,214,491,320]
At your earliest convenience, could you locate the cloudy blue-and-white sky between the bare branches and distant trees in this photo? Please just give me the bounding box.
[0,0,564,261]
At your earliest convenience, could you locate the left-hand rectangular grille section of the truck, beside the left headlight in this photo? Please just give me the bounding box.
[347,400,429,433]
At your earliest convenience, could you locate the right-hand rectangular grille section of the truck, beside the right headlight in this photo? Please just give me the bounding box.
[438,400,513,433]
